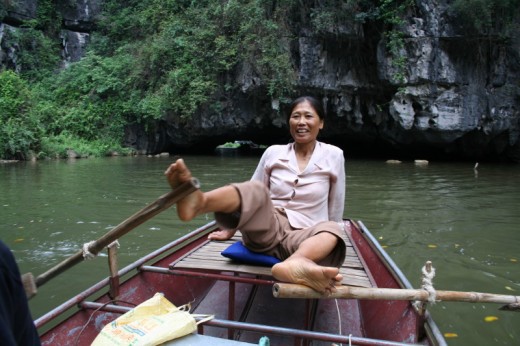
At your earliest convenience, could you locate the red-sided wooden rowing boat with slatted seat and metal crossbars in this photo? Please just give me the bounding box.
[35,220,446,345]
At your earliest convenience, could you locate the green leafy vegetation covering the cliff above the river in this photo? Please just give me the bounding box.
[0,0,520,159]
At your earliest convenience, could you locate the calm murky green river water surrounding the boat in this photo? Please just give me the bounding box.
[0,156,520,345]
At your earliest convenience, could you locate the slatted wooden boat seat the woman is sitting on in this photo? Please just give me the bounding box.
[169,222,375,287]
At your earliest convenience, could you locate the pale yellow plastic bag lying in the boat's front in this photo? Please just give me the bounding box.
[92,293,213,346]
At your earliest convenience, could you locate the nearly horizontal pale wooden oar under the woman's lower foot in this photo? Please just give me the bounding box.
[273,283,520,310]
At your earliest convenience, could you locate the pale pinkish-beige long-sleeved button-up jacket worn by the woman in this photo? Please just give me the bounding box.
[251,142,345,228]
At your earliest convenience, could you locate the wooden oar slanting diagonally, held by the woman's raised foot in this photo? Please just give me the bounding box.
[22,178,200,298]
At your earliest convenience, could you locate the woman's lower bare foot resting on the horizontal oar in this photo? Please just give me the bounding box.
[271,256,343,295]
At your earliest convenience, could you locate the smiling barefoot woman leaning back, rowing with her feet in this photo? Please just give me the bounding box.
[165,96,345,294]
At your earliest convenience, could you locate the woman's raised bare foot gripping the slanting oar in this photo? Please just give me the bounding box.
[164,159,204,221]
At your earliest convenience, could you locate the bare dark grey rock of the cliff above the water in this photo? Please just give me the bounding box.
[0,0,520,161]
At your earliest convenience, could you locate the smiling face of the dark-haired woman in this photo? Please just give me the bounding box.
[289,101,323,144]
